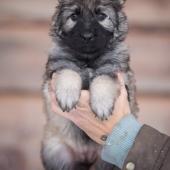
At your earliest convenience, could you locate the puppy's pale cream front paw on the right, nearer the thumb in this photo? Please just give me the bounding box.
[90,75,119,120]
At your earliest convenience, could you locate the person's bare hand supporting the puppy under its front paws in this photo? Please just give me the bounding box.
[50,73,130,144]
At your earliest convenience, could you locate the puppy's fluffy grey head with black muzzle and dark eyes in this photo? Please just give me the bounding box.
[51,0,128,54]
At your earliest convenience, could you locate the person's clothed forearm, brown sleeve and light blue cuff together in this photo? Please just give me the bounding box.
[102,116,170,170]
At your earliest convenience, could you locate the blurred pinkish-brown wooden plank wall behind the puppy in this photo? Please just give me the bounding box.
[0,0,170,170]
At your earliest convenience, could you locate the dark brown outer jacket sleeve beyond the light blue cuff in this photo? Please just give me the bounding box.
[123,125,170,170]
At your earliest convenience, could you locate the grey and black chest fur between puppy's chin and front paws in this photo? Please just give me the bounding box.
[46,43,130,90]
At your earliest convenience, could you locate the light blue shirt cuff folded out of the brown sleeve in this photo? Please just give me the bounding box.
[101,115,142,168]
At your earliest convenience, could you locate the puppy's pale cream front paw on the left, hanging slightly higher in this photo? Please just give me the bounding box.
[53,69,82,112]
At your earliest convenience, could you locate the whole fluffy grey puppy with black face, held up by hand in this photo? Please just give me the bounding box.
[42,0,138,170]
